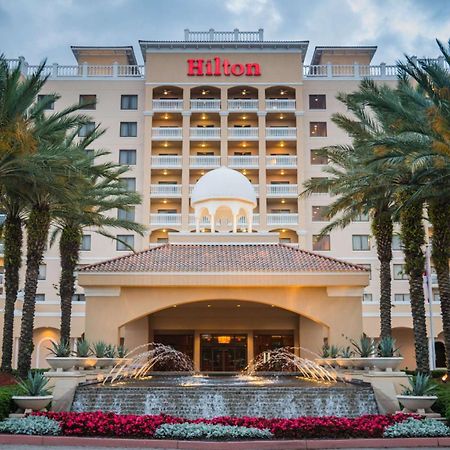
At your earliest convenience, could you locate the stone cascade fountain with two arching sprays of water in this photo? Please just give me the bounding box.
[72,343,378,419]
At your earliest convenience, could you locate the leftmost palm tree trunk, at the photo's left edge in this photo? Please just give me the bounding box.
[1,215,23,372]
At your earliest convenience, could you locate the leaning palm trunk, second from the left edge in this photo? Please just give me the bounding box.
[18,205,50,378]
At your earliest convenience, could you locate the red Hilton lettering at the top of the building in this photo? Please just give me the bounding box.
[187,56,261,77]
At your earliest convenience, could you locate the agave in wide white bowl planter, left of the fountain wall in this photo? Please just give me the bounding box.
[12,372,53,412]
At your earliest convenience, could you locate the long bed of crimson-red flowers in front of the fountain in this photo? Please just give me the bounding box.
[31,412,414,439]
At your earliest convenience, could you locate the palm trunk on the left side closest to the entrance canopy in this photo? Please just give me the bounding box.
[59,225,82,342]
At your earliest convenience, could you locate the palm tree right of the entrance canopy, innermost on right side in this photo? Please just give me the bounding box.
[304,94,394,337]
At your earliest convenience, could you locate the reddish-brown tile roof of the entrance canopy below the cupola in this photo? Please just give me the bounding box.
[79,244,367,273]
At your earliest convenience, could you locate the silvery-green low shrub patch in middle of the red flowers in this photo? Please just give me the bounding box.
[155,423,273,441]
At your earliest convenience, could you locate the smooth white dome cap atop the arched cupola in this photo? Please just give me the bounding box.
[191,166,256,206]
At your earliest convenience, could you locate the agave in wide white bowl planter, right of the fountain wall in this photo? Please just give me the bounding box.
[397,373,437,414]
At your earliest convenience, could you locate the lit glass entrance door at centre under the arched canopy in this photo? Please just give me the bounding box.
[200,334,247,372]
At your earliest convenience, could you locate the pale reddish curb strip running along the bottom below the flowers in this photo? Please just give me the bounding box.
[0,434,450,450]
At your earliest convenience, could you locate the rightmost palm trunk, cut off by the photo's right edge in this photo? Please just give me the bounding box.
[428,200,450,373]
